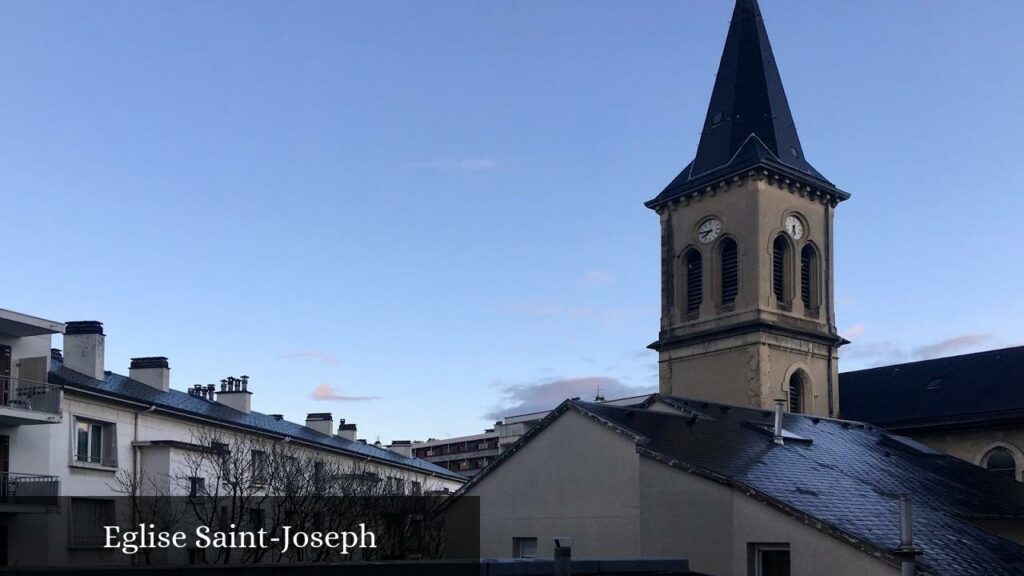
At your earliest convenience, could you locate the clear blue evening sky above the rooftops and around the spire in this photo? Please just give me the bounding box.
[0,0,1024,442]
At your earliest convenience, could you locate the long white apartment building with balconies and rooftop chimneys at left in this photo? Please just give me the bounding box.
[0,310,466,565]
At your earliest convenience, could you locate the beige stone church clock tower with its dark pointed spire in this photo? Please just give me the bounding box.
[646,0,850,416]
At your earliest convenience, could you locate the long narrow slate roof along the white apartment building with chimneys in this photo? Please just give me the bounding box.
[49,358,466,481]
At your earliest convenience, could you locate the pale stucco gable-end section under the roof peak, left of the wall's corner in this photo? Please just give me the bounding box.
[469,411,640,558]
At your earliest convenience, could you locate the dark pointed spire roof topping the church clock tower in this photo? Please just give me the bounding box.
[647,0,849,207]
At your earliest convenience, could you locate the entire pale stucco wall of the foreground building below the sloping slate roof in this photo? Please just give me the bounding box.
[469,411,898,576]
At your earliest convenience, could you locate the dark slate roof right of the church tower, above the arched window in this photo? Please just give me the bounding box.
[839,346,1024,430]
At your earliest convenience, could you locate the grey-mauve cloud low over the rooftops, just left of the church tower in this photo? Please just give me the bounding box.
[484,376,654,420]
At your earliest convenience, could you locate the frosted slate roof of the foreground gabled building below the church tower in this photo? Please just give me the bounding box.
[462,395,1024,576]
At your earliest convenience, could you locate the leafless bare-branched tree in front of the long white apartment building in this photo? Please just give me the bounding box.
[166,428,452,563]
